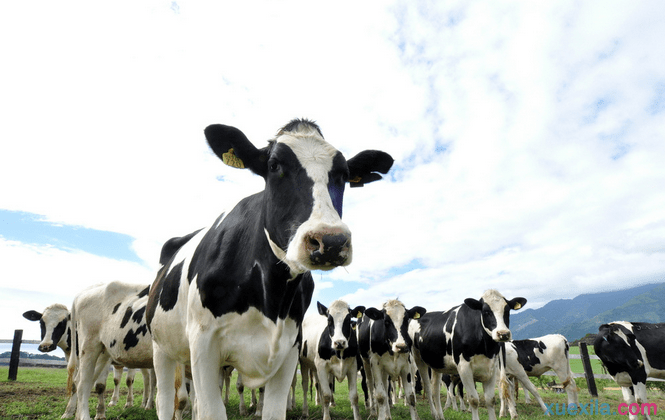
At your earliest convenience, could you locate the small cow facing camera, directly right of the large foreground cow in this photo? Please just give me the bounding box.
[300,300,365,420]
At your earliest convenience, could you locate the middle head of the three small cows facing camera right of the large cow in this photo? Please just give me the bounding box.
[365,299,427,353]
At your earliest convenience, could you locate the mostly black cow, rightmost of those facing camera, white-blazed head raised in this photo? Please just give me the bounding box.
[409,290,526,420]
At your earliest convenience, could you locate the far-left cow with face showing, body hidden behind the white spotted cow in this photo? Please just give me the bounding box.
[23,303,154,419]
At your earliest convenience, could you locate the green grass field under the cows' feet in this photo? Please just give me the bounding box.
[0,367,665,420]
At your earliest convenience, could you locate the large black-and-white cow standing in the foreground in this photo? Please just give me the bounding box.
[148,120,393,420]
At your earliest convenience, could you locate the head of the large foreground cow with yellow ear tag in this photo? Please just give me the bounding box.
[205,120,393,273]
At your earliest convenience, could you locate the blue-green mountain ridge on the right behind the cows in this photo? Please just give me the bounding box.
[510,283,665,341]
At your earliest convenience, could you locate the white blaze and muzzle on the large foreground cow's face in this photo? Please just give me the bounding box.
[277,129,353,272]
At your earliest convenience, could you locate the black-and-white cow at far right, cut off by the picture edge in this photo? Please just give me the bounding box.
[593,321,665,420]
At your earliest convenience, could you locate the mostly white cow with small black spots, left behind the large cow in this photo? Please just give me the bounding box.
[67,282,153,420]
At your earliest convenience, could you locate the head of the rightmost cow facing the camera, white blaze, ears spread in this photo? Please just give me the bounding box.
[464,290,526,342]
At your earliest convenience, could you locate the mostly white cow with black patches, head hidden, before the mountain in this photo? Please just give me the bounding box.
[499,334,579,417]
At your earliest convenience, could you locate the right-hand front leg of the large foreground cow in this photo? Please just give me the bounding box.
[261,348,298,420]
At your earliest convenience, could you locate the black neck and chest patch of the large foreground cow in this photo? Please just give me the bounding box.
[190,192,311,322]
